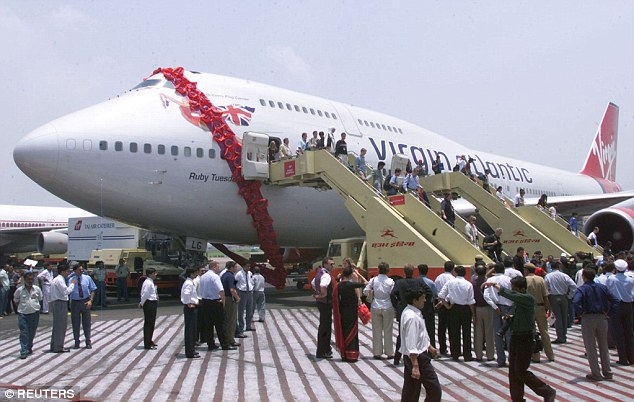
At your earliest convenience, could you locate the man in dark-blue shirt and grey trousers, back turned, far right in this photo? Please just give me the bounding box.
[572,265,619,381]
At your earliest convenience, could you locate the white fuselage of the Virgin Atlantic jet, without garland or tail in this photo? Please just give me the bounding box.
[14,73,602,247]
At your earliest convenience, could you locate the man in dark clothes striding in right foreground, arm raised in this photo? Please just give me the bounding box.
[484,276,557,402]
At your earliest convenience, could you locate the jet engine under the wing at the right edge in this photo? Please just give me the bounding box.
[583,198,634,252]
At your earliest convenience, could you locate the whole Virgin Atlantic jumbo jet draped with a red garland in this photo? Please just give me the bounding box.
[14,68,634,282]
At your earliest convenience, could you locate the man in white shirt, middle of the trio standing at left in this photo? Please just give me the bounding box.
[49,264,77,353]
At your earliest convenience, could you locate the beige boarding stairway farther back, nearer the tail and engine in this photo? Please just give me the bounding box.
[421,172,597,256]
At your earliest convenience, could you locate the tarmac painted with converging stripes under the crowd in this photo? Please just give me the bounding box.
[0,289,634,402]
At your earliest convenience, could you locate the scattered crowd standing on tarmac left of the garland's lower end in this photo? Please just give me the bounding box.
[0,261,266,359]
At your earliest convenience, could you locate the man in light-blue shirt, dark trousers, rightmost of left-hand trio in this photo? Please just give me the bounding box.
[70,261,97,349]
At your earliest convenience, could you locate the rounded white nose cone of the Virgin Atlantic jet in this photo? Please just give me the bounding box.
[13,123,59,183]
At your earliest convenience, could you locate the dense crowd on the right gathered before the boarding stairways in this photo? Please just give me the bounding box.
[312,247,634,401]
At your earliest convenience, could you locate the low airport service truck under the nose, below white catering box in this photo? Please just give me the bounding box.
[88,248,183,296]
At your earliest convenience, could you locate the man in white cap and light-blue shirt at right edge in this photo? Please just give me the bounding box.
[607,259,634,366]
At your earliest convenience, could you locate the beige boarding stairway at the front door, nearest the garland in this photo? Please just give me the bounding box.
[262,150,489,267]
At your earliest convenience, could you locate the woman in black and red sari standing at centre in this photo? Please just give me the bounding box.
[332,264,365,362]
